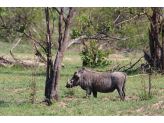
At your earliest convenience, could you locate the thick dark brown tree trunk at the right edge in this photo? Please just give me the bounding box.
[144,7,164,72]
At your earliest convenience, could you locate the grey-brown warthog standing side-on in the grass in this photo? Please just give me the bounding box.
[66,68,126,100]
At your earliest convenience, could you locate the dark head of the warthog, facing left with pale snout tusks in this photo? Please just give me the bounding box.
[66,68,85,88]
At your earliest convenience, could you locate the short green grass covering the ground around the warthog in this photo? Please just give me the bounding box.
[0,42,164,116]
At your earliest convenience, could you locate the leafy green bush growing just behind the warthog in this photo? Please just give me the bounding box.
[80,40,111,67]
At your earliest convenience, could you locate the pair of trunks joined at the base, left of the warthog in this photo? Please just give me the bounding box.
[45,7,74,105]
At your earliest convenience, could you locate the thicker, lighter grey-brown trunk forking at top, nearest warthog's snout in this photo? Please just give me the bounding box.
[49,7,74,102]
